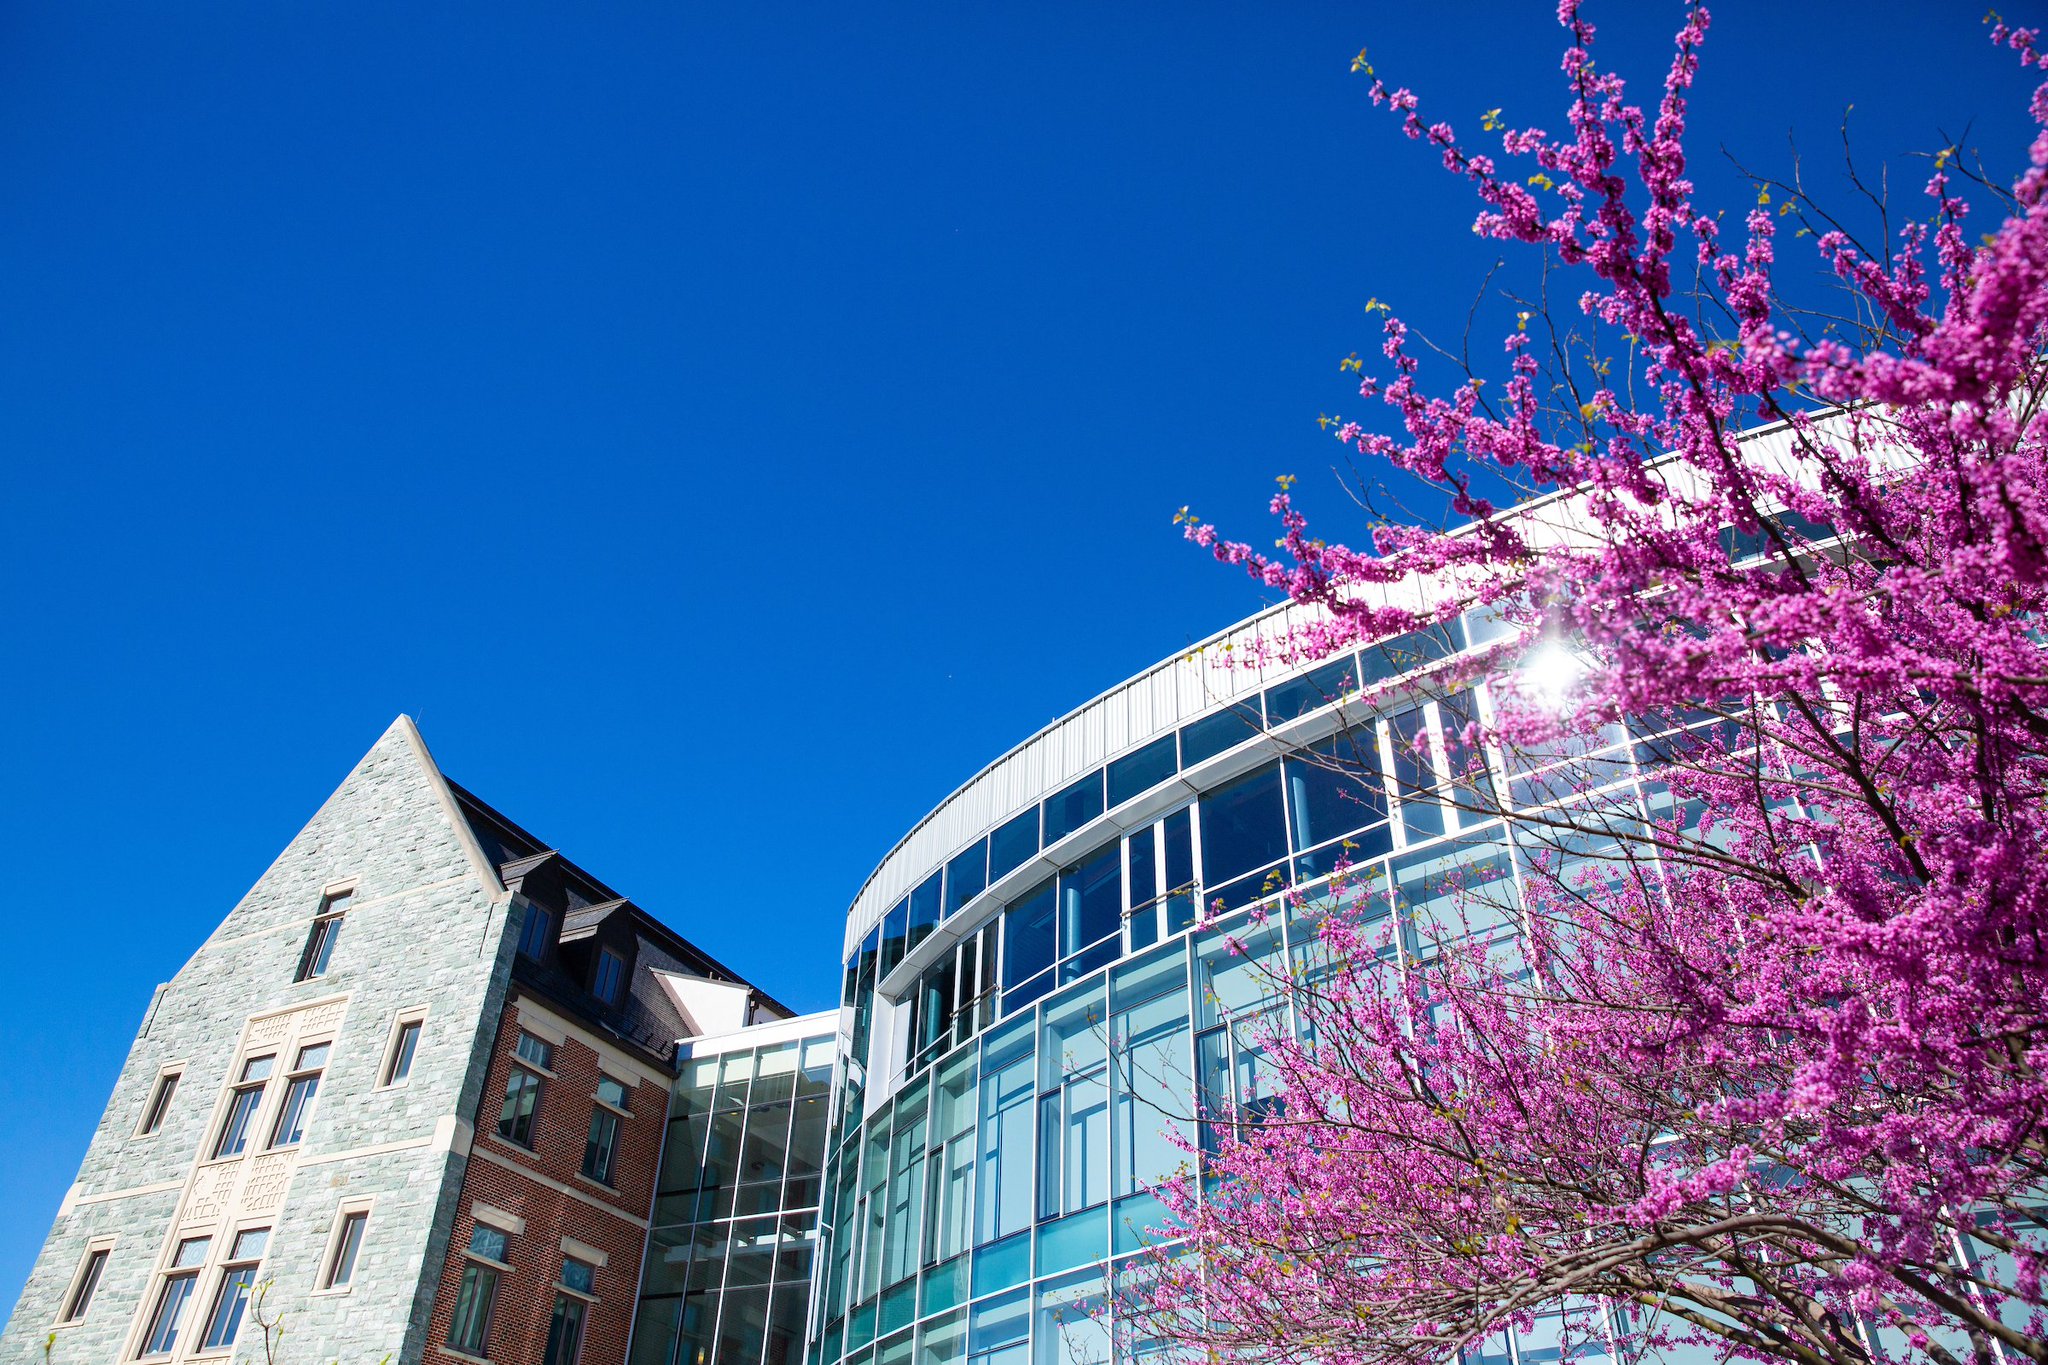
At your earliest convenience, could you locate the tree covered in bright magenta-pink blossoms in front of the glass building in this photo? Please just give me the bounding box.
[1126,10,2048,1365]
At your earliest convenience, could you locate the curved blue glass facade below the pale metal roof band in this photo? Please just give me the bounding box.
[809,601,1655,1365]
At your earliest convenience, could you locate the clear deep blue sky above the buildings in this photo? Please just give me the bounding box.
[0,0,2030,1304]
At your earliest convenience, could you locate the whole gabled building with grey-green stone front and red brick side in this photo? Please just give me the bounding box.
[0,716,806,1365]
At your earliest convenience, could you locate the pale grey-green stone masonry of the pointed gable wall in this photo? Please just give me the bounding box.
[0,718,528,1365]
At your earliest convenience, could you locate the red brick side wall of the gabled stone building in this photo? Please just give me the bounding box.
[426,990,668,1365]
